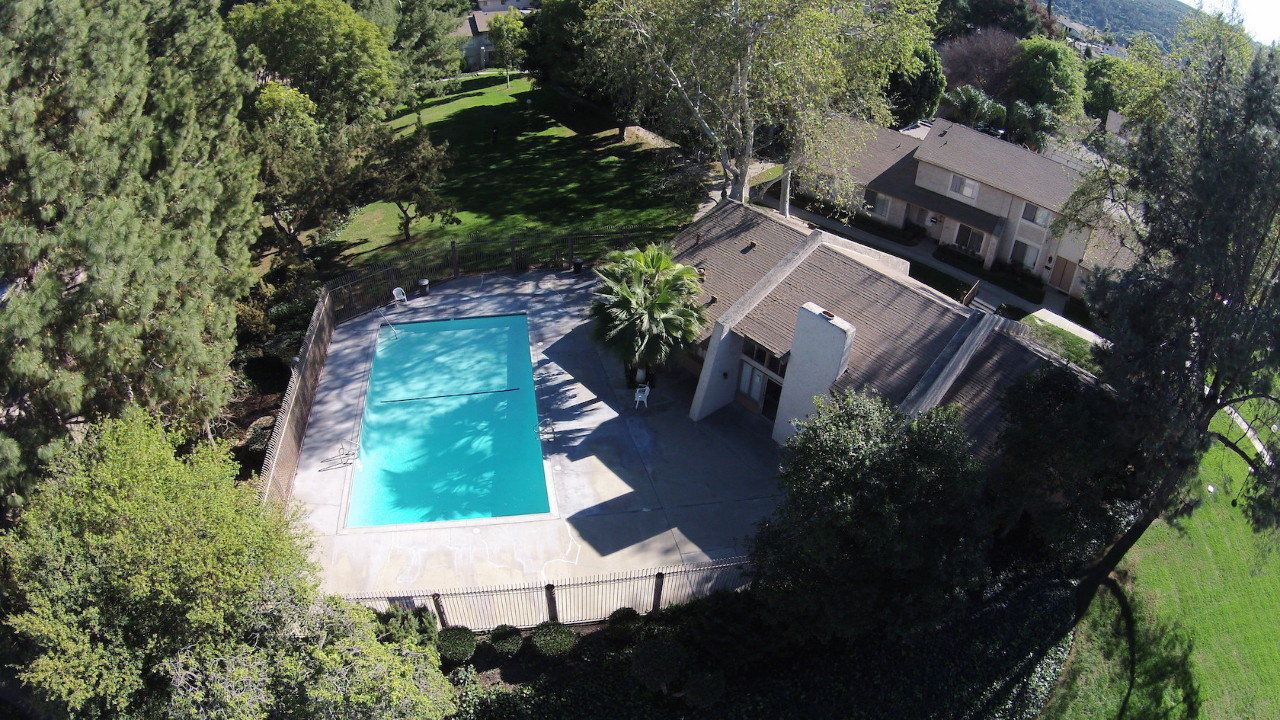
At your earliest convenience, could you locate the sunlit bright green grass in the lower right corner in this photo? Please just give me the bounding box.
[1043,409,1280,720]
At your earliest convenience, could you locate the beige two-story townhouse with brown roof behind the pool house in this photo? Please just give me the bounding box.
[803,120,1128,297]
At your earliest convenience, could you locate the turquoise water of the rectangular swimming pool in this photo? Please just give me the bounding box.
[347,315,549,528]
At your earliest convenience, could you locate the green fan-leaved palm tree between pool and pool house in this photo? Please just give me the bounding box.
[590,245,707,382]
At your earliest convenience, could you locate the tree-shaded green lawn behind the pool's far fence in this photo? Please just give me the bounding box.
[335,76,705,265]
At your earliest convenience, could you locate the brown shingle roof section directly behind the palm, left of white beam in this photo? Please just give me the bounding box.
[672,201,809,332]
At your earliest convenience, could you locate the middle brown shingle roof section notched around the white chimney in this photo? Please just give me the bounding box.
[735,245,972,404]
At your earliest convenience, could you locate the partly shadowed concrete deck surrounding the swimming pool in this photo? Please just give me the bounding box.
[292,272,780,594]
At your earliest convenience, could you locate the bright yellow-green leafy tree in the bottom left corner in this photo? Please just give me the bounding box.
[0,409,452,720]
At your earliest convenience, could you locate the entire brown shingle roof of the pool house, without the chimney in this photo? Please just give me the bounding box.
[675,201,1047,455]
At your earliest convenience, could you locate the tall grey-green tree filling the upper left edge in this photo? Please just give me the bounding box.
[0,0,257,489]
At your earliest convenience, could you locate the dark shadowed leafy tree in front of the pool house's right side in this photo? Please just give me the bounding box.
[751,395,991,642]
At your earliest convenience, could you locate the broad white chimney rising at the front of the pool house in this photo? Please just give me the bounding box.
[773,302,854,443]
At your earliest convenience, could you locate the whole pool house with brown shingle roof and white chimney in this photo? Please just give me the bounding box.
[675,202,1050,452]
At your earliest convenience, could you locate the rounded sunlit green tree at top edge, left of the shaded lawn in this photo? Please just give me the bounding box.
[227,0,396,124]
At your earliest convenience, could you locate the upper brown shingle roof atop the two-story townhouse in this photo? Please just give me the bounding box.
[915,120,1080,211]
